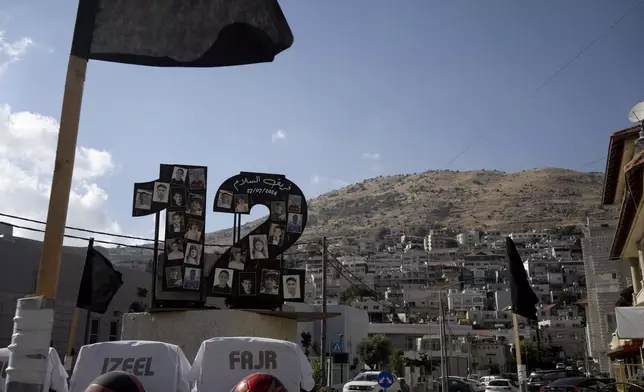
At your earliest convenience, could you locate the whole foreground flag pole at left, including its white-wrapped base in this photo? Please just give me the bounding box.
[5,54,87,392]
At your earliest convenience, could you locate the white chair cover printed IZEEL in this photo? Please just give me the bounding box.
[69,340,190,392]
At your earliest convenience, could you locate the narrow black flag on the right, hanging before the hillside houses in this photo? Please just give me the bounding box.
[505,237,539,320]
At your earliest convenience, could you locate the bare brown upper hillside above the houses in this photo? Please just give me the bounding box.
[206,168,617,243]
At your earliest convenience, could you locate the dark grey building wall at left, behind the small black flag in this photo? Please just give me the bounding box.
[0,237,151,356]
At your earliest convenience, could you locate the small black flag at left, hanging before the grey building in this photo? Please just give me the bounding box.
[76,240,123,314]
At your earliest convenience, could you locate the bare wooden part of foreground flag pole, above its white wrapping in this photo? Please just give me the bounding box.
[36,56,87,299]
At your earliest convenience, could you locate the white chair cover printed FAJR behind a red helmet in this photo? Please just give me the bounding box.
[190,337,315,392]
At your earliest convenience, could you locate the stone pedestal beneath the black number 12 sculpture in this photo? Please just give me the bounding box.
[121,310,299,362]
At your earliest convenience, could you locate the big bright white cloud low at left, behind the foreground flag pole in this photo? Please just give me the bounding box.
[0,105,125,245]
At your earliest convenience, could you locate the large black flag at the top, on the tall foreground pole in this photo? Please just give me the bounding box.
[71,0,293,67]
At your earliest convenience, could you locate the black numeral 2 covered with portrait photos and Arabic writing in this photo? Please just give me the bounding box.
[208,172,308,309]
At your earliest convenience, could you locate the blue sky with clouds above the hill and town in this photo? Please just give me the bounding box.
[0,0,644,245]
